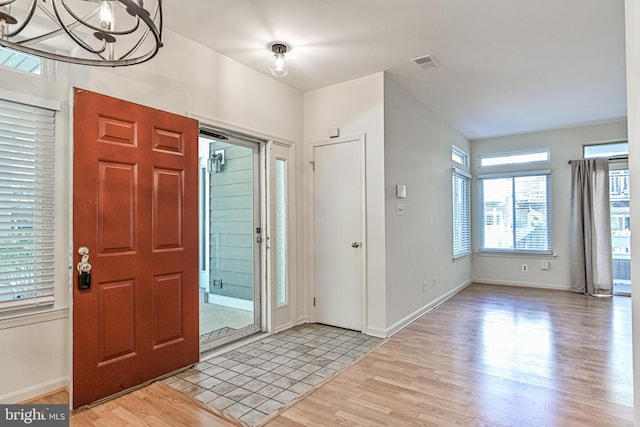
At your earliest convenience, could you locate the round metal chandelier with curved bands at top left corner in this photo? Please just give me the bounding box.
[0,0,162,67]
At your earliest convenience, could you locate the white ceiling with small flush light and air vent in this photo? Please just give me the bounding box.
[160,0,626,139]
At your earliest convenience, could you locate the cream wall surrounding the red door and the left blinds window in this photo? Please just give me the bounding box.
[0,31,302,403]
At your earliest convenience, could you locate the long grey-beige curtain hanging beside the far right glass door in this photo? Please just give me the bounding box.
[570,159,613,296]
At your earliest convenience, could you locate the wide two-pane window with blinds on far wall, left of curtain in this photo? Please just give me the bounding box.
[478,171,552,254]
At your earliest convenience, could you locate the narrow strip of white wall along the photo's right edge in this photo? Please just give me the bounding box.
[625,0,640,425]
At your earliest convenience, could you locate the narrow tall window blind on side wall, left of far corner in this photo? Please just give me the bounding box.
[453,168,471,258]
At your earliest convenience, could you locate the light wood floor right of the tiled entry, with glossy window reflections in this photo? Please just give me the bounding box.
[268,285,633,427]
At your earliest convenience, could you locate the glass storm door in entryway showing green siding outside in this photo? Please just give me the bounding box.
[198,129,262,352]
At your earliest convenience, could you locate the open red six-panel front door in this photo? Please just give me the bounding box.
[72,89,199,408]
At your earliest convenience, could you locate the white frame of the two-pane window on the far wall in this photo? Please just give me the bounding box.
[478,169,553,255]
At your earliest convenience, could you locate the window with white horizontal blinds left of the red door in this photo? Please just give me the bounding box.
[0,100,55,312]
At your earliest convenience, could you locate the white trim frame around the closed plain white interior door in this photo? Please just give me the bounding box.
[308,134,368,333]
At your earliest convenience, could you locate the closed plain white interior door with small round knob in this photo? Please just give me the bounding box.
[314,139,365,331]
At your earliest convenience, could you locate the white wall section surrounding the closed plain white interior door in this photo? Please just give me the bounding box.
[299,73,385,336]
